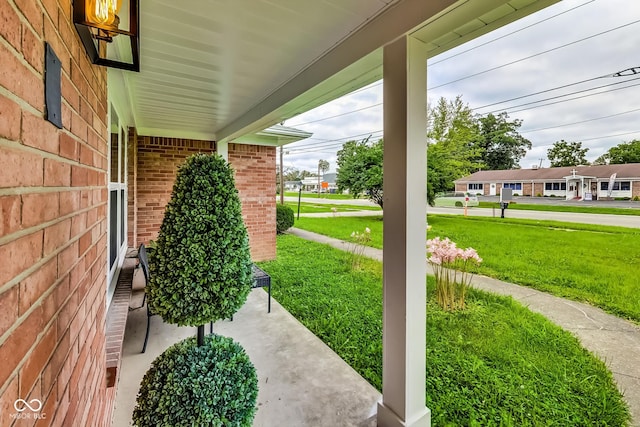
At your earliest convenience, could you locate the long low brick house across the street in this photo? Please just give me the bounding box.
[455,163,640,200]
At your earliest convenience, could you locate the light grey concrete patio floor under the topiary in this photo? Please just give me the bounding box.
[112,269,381,427]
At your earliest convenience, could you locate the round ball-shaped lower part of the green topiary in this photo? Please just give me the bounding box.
[133,335,258,427]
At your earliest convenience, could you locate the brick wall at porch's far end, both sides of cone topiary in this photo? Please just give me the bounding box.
[129,139,276,261]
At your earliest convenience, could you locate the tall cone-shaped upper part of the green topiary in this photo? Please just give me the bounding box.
[147,154,252,326]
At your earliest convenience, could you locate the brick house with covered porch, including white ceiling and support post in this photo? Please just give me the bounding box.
[0,0,555,426]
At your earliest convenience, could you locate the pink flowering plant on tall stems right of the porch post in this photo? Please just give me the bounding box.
[427,237,482,311]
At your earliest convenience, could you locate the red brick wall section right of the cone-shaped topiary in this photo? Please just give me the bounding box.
[229,144,276,261]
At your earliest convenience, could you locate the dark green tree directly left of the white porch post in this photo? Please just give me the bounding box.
[336,138,383,207]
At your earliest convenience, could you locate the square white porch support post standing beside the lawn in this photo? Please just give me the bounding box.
[377,36,431,427]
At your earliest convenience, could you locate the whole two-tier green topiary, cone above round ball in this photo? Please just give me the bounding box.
[133,154,258,427]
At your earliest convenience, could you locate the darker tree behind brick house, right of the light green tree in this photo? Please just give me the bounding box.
[476,112,531,170]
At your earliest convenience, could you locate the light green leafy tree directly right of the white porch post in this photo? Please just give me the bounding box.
[427,96,482,205]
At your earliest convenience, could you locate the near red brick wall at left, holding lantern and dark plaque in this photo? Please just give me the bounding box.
[0,0,113,426]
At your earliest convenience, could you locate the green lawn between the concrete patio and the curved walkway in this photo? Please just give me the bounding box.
[260,235,629,426]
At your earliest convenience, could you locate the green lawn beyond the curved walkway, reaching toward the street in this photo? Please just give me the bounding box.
[295,215,640,322]
